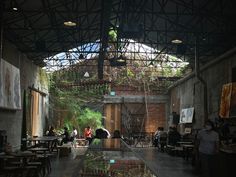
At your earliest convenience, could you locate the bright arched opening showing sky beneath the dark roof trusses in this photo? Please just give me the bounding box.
[44,39,188,72]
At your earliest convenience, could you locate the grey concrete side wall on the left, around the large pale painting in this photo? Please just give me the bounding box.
[0,41,48,149]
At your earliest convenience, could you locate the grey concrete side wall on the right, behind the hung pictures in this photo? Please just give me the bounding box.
[170,48,236,131]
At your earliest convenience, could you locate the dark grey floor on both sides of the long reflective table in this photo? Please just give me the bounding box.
[49,147,197,177]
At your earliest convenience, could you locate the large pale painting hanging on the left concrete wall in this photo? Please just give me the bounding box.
[0,59,21,109]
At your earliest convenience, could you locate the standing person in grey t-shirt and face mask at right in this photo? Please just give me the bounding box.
[197,120,219,177]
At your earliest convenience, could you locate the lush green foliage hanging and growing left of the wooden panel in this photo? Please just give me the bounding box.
[50,68,103,134]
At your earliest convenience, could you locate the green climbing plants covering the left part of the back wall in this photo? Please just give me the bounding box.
[50,70,103,131]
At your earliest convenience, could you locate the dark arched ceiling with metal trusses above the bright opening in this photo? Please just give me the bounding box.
[0,0,236,78]
